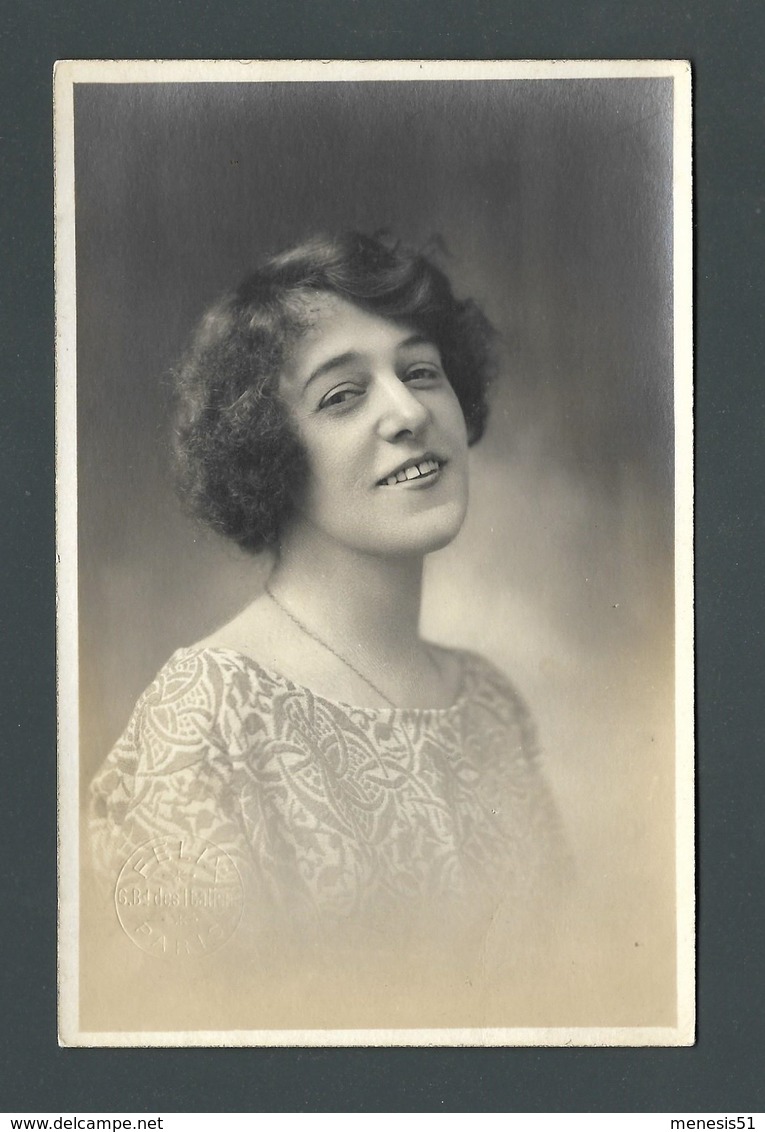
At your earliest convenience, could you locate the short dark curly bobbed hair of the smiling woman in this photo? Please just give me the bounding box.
[173,232,495,551]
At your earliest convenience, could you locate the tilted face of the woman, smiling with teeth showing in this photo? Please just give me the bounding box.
[281,294,467,556]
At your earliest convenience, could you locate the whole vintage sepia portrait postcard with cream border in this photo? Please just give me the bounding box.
[54,60,695,1046]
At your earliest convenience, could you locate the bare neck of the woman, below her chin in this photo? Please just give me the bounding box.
[268,525,422,664]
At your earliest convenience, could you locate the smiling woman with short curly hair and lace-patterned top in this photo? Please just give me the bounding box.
[92,233,566,1026]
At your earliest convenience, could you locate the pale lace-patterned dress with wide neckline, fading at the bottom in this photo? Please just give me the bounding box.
[91,648,565,945]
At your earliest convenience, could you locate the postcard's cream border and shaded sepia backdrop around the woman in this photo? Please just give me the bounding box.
[55,61,695,1046]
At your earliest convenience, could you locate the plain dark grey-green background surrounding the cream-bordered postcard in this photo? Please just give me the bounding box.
[1,2,764,1112]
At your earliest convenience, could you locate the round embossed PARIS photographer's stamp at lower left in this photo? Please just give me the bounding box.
[114,835,244,959]
